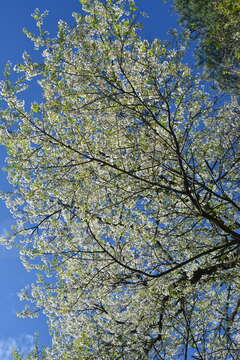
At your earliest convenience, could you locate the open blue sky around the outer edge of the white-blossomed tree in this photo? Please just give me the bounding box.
[0,0,177,360]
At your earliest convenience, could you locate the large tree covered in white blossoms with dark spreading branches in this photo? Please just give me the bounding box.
[1,0,240,360]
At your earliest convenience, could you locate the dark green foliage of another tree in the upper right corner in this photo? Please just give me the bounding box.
[172,0,240,95]
